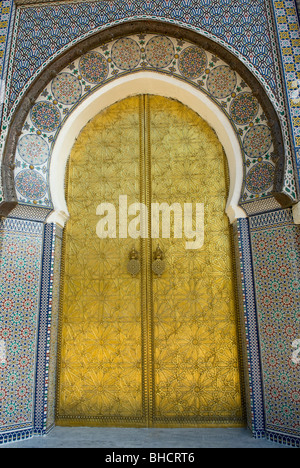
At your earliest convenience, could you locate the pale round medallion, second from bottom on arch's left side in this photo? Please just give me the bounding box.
[18,134,49,165]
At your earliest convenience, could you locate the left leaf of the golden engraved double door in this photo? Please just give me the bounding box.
[57,97,146,425]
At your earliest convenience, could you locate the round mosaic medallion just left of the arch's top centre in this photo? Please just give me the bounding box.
[111,37,141,70]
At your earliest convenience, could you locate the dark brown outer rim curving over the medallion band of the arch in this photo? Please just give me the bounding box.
[0,20,292,217]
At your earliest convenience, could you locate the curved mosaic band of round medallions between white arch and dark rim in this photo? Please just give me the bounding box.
[15,34,277,207]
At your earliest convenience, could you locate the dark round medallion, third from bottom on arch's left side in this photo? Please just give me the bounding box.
[30,101,60,133]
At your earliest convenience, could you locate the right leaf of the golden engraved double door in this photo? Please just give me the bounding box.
[149,96,242,425]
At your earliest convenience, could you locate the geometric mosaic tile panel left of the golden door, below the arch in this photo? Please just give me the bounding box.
[0,219,43,441]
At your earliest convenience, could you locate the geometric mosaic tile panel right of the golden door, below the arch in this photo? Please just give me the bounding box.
[250,210,300,445]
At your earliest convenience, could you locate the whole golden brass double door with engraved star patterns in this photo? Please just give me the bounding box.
[57,95,243,427]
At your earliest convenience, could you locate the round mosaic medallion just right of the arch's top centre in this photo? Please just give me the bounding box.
[146,36,175,68]
